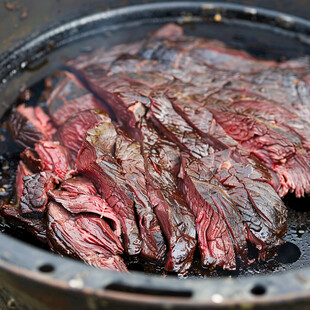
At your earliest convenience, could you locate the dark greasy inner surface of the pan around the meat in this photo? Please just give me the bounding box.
[0,5,310,278]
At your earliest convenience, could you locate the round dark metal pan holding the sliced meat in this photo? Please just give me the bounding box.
[0,1,310,310]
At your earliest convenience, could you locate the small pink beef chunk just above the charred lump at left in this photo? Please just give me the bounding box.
[34,141,74,180]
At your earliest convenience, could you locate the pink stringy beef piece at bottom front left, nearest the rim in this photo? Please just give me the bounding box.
[47,202,127,271]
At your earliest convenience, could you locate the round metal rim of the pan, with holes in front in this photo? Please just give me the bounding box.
[0,2,310,309]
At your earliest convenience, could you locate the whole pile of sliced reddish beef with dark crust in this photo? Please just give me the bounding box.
[1,24,310,274]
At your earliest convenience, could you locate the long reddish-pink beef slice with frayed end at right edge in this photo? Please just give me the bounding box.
[209,108,310,197]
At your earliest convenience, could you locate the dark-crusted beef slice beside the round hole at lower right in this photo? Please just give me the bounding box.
[179,150,287,259]
